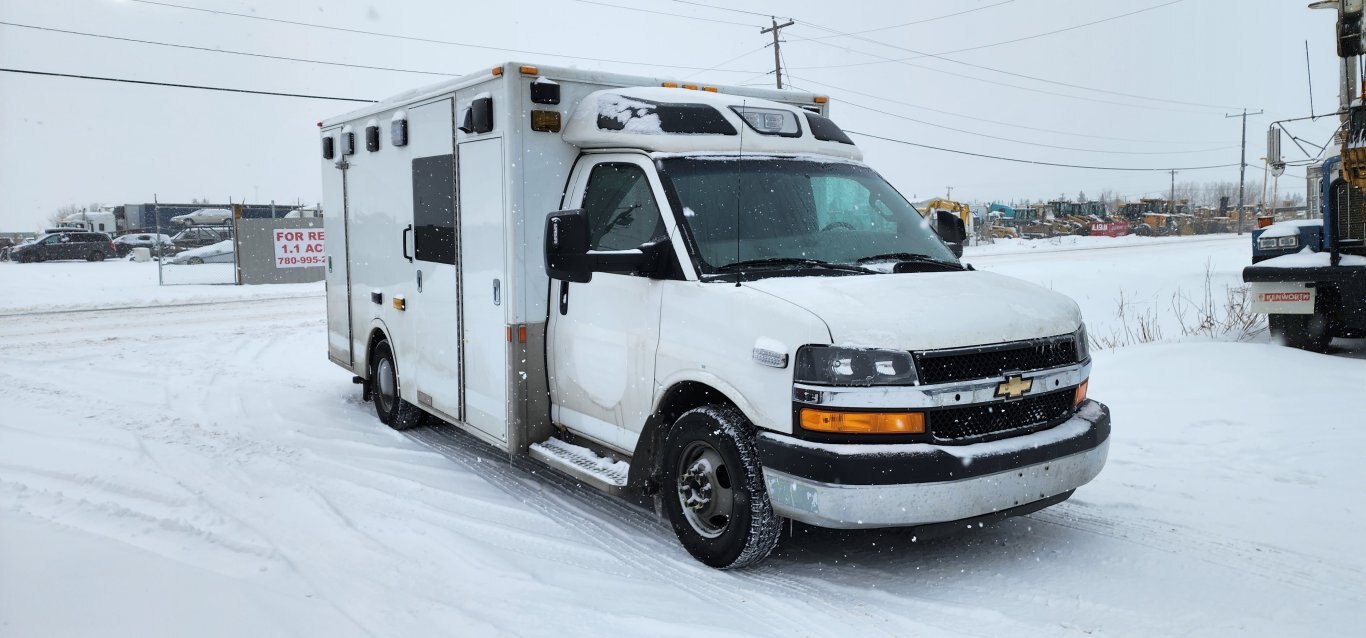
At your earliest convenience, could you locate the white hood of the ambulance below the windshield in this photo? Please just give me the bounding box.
[744,271,1082,350]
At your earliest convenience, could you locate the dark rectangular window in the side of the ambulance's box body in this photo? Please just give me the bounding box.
[413,154,455,264]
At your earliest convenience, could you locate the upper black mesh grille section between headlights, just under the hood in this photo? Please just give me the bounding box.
[914,335,1078,385]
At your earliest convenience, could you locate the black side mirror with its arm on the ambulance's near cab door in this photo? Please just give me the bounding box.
[545,209,673,284]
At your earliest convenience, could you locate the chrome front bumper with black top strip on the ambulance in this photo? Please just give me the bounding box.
[758,400,1111,529]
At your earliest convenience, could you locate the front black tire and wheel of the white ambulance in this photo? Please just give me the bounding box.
[660,406,783,570]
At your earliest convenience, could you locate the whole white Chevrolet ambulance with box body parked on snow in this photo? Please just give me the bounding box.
[320,63,1109,567]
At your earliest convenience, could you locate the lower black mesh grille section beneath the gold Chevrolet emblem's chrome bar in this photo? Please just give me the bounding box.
[929,388,1076,443]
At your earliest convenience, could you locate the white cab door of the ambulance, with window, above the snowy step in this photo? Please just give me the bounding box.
[546,154,668,451]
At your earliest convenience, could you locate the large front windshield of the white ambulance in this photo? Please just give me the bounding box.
[661,157,955,272]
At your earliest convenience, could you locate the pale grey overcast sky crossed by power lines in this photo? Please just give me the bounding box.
[0,0,1337,231]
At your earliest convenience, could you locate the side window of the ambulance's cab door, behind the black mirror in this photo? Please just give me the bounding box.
[583,164,667,250]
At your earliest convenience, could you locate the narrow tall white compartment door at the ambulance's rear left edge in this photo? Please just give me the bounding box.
[322,129,355,369]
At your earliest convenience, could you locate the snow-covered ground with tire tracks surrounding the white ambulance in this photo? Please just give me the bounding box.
[0,238,1366,637]
